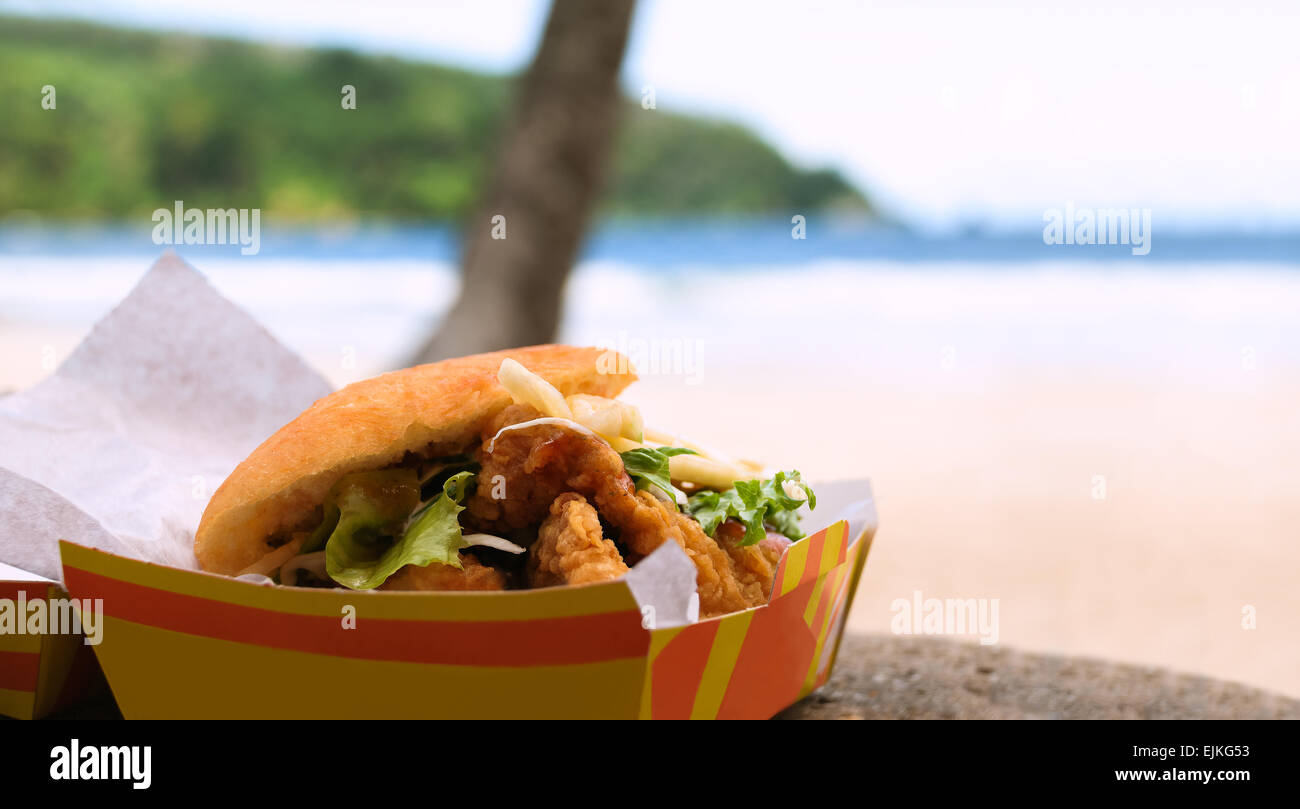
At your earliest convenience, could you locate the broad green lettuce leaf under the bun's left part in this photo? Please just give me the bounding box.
[325,470,473,589]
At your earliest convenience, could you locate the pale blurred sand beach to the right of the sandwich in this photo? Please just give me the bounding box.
[618,378,1300,696]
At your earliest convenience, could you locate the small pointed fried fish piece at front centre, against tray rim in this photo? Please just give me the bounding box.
[528,492,628,587]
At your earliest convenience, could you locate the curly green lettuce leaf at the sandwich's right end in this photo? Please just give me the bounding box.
[686,470,816,545]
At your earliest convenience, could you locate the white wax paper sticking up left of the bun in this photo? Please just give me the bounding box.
[0,251,330,580]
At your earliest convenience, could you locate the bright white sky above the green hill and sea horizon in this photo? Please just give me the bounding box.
[0,0,1300,226]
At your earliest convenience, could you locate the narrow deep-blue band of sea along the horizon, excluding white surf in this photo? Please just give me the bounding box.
[0,217,1300,271]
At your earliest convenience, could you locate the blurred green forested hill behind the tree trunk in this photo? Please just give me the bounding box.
[0,17,867,219]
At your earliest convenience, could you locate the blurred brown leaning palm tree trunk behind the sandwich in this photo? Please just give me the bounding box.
[416,0,634,362]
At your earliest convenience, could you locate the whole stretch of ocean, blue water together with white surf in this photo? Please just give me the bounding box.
[0,222,1300,388]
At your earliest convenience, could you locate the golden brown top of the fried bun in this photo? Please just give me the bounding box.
[194,346,637,575]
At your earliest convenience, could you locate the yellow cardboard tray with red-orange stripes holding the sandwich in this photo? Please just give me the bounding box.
[60,489,875,719]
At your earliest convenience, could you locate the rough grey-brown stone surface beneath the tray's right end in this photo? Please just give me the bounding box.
[777,635,1300,719]
